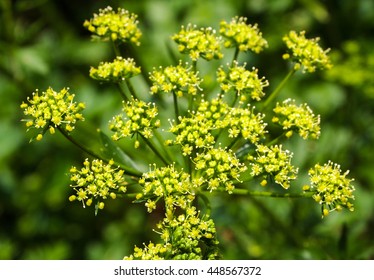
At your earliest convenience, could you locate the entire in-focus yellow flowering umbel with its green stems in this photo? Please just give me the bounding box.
[21,7,355,259]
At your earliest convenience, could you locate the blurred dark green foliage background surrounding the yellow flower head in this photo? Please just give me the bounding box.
[0,0,374,259]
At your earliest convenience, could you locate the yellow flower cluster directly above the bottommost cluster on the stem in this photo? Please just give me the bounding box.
[136,165,195,214]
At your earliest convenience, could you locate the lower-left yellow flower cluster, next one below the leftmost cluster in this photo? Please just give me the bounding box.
[69,159,126,209]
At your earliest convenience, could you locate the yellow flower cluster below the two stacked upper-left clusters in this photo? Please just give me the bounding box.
[109,99,160,141]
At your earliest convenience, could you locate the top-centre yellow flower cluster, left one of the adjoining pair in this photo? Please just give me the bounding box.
[171,24,223,61]
